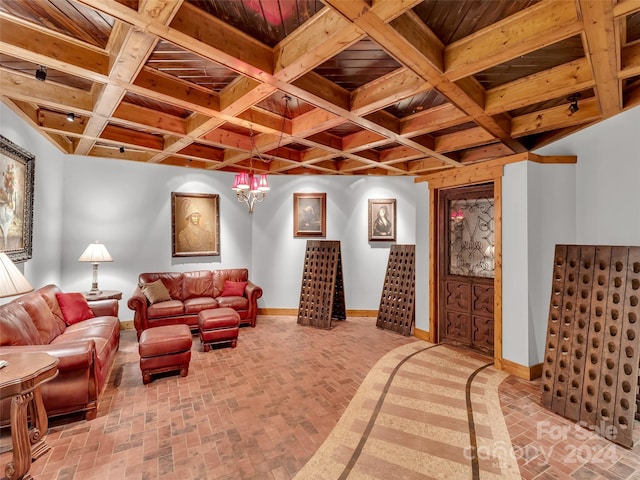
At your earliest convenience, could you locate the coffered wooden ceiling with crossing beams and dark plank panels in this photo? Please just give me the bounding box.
[0,0,640,176]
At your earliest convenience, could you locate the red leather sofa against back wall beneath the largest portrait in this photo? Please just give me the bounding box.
[127,268,262,338]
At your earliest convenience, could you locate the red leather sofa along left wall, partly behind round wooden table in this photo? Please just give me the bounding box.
[0,285,120,425]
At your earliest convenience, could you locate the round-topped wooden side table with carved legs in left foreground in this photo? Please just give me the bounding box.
[0,352,59,479]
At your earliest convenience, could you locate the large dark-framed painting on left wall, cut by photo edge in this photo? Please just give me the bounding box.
[0,135,36,262]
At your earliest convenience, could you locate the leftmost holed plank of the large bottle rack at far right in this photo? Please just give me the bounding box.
[542,245,567,409]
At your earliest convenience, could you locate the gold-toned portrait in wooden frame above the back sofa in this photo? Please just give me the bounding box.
[171,192,220,257]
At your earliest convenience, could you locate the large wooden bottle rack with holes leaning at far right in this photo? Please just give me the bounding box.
[542,245,640,448]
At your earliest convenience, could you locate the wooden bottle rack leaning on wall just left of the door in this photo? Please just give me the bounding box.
[376,245,416,336]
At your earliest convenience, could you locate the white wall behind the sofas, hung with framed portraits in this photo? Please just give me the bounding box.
[1,105,428,318]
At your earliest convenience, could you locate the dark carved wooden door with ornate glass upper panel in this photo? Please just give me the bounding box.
[438,184,494,355]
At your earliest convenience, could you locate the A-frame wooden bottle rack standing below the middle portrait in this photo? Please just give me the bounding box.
[298,240,347,329]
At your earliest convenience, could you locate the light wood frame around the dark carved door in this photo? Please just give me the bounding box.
[427,165,504,370]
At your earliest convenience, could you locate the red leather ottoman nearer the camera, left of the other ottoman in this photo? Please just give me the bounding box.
[138,325,191,384]
